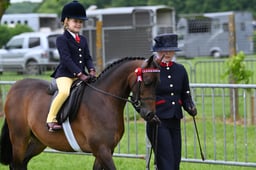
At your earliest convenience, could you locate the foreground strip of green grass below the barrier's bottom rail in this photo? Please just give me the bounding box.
[0,153,255,170]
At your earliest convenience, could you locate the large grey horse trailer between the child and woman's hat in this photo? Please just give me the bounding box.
[82,5,175,65]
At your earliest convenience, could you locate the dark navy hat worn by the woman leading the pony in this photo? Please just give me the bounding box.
[152,34,180,52]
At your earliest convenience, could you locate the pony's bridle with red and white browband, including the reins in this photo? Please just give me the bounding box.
[85,67,160,111]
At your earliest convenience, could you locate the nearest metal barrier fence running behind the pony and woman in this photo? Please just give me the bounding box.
[0,81,256,167]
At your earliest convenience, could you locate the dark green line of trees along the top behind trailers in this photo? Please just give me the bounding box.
[36,0,256,18]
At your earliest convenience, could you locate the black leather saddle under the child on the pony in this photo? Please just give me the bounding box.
[47,79,86,124]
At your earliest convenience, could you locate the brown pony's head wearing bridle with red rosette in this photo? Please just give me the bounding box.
[130,55,161,121]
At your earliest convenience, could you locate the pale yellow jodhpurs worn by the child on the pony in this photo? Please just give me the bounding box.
[46,77,76,123]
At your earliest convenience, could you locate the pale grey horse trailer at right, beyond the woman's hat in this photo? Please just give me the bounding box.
[177,11,253,58]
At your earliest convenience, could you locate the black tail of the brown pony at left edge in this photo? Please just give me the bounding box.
[0,120,12,165]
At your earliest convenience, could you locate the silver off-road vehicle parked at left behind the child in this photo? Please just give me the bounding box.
[0,32,60,74]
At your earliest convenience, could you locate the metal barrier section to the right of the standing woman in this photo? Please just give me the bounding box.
[183,84,256,167]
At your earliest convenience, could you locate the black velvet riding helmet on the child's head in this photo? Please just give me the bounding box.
[61,0,87,22]
